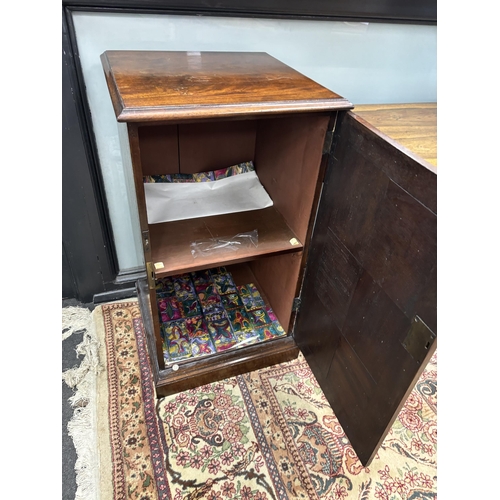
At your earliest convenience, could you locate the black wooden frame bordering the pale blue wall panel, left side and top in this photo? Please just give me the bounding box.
[62,0,437,302]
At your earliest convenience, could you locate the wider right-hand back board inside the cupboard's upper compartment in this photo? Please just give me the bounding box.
[179,120,257,174]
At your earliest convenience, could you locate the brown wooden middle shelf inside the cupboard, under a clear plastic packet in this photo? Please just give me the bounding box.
[149,207,303,277]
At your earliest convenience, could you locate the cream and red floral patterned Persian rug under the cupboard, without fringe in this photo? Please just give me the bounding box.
[68,301,437,500]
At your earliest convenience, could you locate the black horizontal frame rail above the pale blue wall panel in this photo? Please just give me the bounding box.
[63,0,437,24]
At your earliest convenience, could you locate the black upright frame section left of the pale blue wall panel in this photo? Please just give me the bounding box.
[62,9,141,303]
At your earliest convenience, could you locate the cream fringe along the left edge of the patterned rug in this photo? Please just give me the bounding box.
[62,307,100,500]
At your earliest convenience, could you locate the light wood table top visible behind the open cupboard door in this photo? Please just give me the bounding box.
[353,103,437,167]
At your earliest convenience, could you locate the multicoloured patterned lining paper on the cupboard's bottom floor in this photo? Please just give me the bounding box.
[156,265,286,366]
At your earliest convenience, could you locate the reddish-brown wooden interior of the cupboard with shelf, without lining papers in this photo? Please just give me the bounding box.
[138,113,331,364]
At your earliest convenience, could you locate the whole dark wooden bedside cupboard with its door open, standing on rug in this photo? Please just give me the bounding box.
[101,51,437,465]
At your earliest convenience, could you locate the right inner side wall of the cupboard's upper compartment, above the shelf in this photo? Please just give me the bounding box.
[255,114,330,241]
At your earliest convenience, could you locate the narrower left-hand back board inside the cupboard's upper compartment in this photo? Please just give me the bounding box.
[139,125,179,175]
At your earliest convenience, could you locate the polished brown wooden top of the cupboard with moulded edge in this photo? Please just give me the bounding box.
[101,51,352,122]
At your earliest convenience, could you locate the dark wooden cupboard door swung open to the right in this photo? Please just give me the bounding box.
[294,112,437,465]
